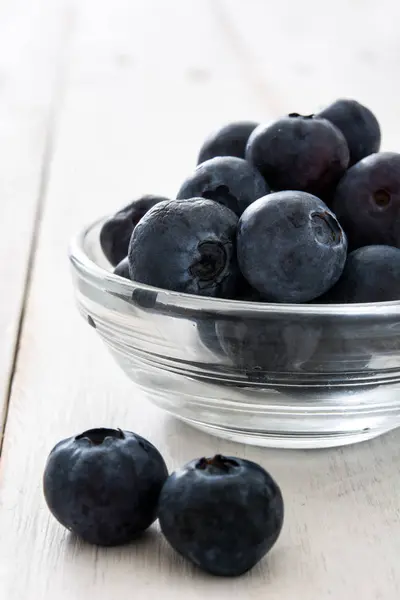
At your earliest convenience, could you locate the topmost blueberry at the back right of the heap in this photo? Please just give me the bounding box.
[317,99,381,166]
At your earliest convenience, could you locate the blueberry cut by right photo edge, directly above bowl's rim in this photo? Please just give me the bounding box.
[323,246,400,304]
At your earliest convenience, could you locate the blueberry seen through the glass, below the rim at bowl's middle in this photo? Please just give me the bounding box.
[216,314,321,381]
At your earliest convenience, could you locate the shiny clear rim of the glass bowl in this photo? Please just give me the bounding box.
[68,216,400,318]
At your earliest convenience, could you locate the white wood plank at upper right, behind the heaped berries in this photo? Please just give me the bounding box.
[210,0,400,151]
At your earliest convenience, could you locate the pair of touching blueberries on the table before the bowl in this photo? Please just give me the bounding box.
[43,429,284,576]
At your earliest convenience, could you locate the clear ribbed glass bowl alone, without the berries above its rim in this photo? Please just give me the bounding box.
[70,221,400,448]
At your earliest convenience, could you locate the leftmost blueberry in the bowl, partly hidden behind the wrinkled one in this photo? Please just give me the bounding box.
[100,195,168,267]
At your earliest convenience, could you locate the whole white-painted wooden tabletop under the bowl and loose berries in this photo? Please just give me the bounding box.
[0,0,400,600]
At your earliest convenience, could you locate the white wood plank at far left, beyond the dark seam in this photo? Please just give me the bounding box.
[0,0,72,436]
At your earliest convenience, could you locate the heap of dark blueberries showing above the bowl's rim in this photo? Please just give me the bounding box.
[100,99,400,303]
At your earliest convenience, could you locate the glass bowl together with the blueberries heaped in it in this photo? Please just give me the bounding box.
[70,101,400,446]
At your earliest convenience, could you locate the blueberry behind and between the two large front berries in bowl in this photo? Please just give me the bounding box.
[177,156,269,217]
